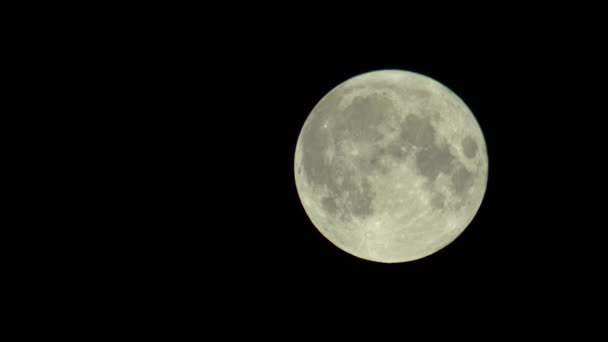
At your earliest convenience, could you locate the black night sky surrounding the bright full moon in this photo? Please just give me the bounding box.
[0,4,605,340]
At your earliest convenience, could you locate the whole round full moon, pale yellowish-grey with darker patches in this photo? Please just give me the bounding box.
[294,70,488,263]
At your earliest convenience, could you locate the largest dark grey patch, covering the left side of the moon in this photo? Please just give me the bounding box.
[297,91,404,222]
